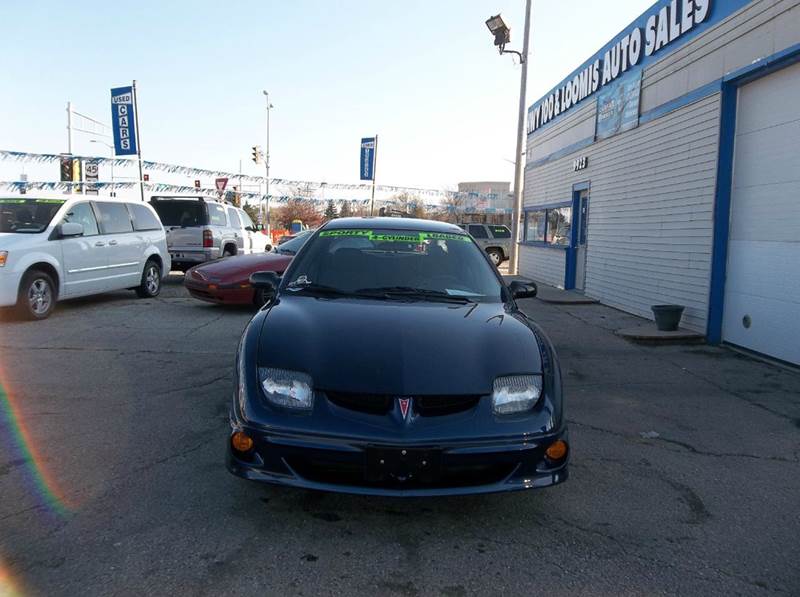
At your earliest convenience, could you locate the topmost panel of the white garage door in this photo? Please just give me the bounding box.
[736,64,800,135]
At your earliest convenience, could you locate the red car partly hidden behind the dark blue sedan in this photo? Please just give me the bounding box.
[183,230,311,307]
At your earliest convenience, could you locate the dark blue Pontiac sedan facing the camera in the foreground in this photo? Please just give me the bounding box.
[227,218,569,496]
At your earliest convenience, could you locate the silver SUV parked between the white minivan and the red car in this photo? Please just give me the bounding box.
[150,196,272,271]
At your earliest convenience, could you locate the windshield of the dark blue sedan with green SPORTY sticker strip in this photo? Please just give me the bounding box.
[285,229,502,302]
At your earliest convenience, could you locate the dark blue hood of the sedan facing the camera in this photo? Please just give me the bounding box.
[257,296,542,396]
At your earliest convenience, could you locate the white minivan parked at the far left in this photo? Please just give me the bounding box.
[0,196,171,319]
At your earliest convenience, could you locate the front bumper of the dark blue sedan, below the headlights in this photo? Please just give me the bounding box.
[226,428,569,497]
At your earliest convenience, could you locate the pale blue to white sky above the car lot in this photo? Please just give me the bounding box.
[0,0,652,189]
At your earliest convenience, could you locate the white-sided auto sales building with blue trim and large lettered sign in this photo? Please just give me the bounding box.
[520,0,800,364]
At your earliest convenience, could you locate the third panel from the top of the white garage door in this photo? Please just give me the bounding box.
[730,182,800,242]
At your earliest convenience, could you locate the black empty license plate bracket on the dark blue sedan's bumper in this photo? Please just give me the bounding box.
[367,447,441,484]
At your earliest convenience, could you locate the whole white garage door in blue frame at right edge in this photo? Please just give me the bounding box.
[722,64,800,364]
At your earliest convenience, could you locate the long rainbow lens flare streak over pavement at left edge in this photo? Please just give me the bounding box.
[0,372,71,516]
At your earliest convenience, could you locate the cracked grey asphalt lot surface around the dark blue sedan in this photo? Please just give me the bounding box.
[0,277,800,596]
